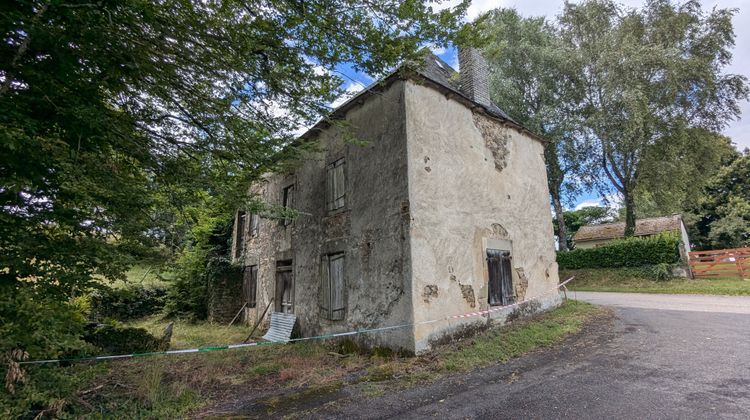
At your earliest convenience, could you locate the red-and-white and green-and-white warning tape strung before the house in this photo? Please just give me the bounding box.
[22,276,575,365]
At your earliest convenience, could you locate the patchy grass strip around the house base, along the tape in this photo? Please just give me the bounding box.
[29,302,607,418]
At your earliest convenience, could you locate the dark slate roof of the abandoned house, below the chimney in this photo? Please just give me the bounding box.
[301,51,536,143]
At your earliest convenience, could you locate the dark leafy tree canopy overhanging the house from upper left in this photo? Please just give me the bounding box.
[0,0,467,295]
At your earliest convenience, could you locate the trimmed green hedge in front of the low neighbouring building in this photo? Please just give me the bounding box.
[557,233,680,270]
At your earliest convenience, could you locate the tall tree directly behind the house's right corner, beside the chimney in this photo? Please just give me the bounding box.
[480,9,595,251]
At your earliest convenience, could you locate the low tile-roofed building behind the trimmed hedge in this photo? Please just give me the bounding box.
[573,214,690,261]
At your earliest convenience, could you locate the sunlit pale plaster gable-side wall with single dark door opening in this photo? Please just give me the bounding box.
[405,82,559,352]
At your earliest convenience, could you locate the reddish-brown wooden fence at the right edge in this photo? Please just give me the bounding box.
[688,248,750,278]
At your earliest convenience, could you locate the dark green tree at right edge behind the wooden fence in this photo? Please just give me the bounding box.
[689,149,750,249]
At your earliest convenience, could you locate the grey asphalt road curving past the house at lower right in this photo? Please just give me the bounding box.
[313,292,750,419]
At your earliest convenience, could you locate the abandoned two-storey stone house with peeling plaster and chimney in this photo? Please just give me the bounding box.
[232,49,560,353]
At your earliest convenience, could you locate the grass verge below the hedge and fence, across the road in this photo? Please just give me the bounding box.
[560,269,750,296]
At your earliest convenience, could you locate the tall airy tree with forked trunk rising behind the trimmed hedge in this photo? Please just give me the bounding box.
[560,0,748,235]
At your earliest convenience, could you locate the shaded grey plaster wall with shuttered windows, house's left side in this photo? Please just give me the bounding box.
[245,82,414,350]
